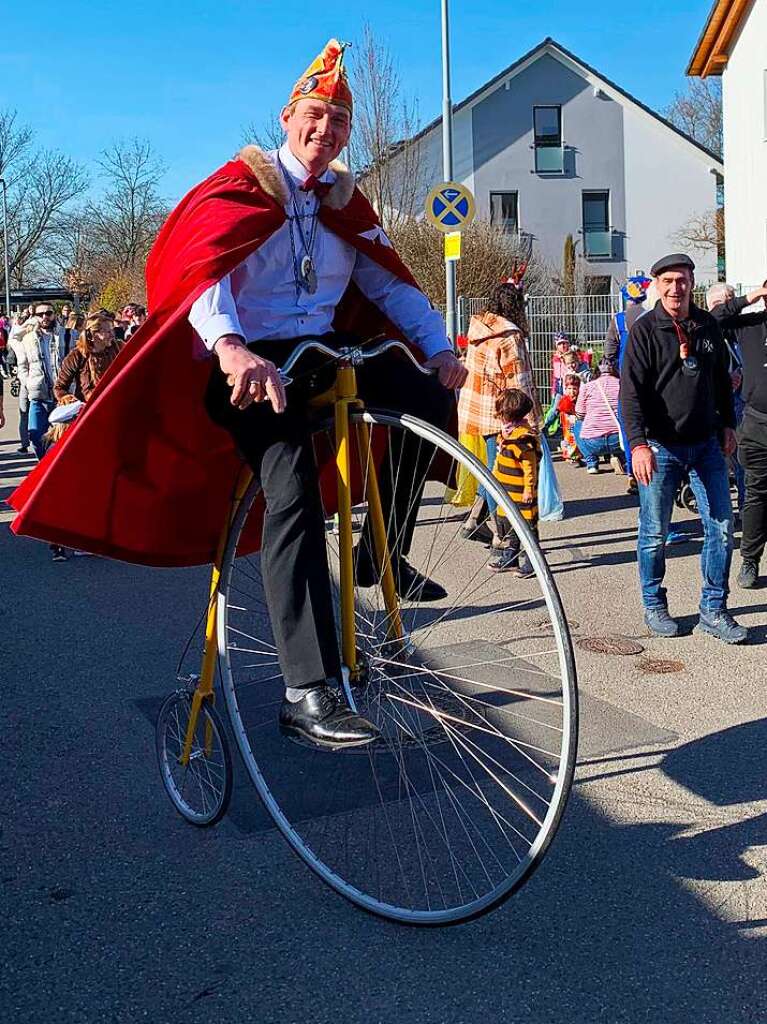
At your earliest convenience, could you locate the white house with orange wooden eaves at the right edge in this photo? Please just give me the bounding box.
[687,0,767,287]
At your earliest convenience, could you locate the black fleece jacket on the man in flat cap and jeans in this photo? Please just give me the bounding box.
[621,301,735,449]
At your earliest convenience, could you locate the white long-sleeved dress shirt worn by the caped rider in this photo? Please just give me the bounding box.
[189,143,451,358]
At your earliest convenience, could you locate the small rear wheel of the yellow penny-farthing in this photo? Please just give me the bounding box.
[156,690,231,828]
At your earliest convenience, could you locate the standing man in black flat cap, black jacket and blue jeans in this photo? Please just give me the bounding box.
[621,253,748,643]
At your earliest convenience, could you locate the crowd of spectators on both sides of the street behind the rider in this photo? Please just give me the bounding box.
[0,262,767,642]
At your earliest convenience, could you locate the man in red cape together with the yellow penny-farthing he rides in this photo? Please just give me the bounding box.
[11,40,576,924]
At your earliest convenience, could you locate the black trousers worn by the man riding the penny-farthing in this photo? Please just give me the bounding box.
[206,335,455,687]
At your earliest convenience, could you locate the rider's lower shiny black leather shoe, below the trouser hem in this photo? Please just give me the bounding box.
[280,686,380,751]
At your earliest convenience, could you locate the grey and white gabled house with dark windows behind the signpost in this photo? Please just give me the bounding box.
[391,39,724,292]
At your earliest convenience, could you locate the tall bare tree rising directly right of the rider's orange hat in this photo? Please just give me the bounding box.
[349,26,429,233]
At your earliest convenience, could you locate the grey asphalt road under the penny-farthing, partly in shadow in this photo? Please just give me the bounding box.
[0,399,767,1024]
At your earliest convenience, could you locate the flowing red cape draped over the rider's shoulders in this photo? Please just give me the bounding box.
[8,159,418,566]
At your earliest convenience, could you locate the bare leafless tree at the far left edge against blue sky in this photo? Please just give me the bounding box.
[0,111,88,285]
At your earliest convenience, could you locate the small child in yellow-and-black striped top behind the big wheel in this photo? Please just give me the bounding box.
[487,388,541,579]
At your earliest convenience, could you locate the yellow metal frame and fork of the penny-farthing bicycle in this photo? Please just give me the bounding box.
[179,359,403,765]
